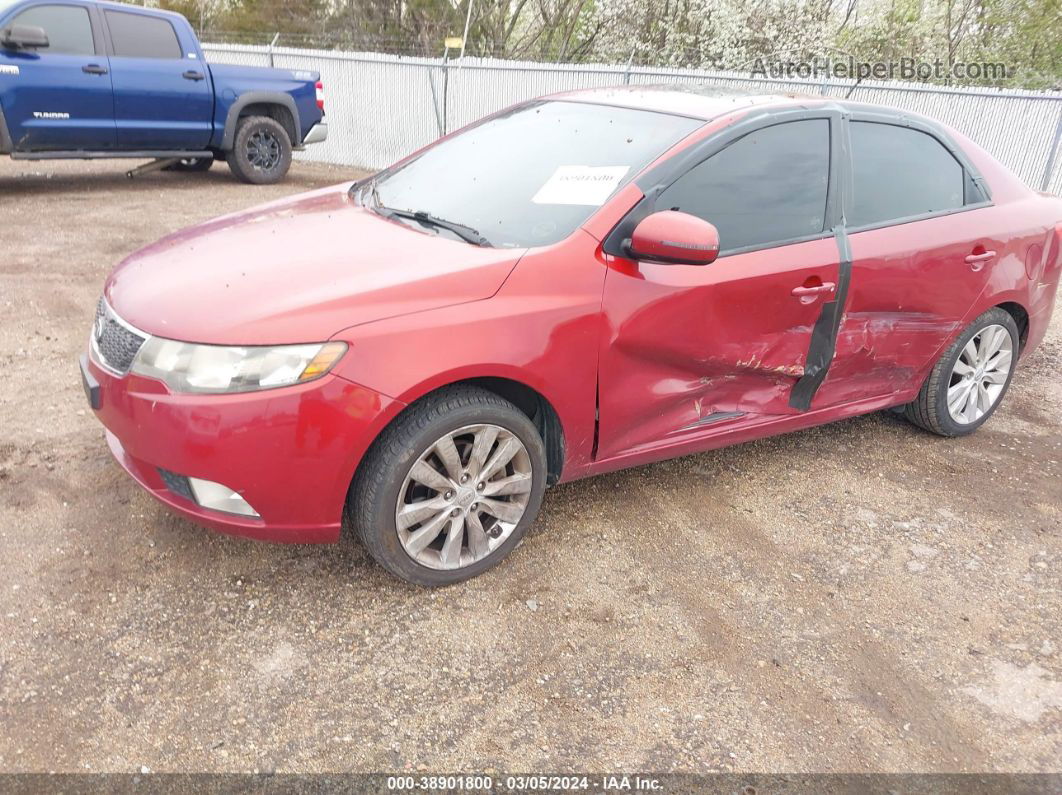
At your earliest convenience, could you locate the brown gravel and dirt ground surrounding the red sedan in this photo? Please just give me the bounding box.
[0,159,1062,772]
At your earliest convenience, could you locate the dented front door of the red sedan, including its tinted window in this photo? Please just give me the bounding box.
[597,118,840,460]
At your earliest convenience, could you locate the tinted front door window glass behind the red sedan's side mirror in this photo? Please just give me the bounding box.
[656,119,829,250]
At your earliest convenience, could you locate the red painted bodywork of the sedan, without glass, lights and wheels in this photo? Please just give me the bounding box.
[88,89,1062,542]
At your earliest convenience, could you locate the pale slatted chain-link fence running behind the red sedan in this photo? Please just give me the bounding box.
[204,45,1062,194]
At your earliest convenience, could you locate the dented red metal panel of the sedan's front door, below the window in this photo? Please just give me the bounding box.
[598,236,839,459]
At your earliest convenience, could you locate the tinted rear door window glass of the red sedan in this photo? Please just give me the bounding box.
[847,121,964,226]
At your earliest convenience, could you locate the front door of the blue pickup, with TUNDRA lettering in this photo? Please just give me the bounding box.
[0,2,115,152]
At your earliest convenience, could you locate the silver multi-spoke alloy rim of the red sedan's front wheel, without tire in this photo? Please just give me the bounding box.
[395,425,533,569]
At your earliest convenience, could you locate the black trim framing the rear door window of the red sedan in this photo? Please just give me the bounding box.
[842,110,993,235]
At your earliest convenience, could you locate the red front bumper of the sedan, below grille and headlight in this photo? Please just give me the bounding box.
[84,357,400,543]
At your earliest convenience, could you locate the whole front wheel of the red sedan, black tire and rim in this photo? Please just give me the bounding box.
[347,386,546,587]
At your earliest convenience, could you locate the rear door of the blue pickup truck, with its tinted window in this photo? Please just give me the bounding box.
[103,8,213,151]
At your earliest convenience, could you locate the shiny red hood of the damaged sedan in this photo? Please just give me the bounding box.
[104,185,525,345]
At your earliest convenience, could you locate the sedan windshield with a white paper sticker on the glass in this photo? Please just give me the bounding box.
[366,102,704,247]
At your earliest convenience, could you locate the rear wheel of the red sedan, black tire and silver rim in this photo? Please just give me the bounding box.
[904,308,1020,436]
